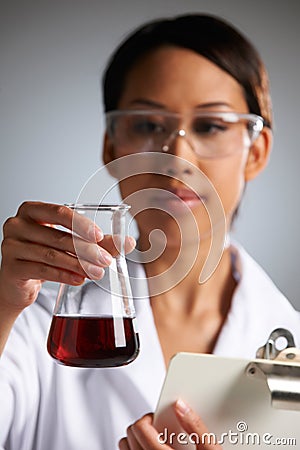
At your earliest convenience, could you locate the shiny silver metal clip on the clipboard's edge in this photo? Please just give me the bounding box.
[246,328,300,410]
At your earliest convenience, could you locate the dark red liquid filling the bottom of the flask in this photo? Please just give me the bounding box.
[47,316,139,367]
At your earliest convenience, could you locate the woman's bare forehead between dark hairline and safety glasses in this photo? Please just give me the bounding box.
[119,46,247,111]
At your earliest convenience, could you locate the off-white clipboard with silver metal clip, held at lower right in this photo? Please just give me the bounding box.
[154,329,300,450]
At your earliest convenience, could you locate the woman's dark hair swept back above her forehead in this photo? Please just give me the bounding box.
[103,14,272,127]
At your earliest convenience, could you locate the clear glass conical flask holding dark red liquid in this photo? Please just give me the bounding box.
[47,204,139,367]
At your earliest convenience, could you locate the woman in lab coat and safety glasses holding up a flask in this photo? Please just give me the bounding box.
[0,15,300,450]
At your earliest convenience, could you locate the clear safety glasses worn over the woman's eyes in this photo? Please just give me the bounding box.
[106,111,263,158]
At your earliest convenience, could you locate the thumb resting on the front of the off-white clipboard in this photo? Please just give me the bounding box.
[174,399,222,450]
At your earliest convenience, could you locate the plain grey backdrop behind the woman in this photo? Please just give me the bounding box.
[0,0,300,308]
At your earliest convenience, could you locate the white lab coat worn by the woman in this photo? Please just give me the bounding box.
[0,246,300,450]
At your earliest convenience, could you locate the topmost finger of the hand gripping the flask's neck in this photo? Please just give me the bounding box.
[17,202,103,242]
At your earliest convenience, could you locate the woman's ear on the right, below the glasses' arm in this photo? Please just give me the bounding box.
[244,128,273,181]
